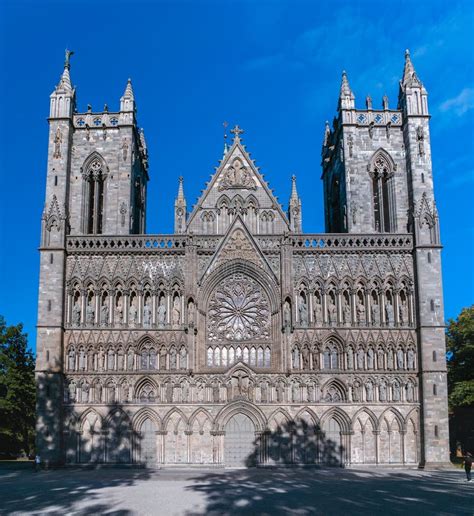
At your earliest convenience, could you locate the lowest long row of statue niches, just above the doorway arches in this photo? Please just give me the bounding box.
[64,377,417,404]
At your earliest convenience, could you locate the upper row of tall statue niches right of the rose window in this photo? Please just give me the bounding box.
[283,295,411,328]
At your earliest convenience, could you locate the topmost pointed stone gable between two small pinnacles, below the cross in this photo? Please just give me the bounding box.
[187,138,290,232]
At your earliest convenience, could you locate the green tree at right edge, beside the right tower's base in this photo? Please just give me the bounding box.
[446,305,474,409]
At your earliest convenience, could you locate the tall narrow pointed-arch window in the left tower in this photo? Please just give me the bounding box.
[82,156,106,235]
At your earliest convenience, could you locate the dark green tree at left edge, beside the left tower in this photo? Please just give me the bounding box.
[0,316,36,455]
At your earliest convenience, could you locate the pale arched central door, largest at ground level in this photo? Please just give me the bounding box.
[224,414,256,468]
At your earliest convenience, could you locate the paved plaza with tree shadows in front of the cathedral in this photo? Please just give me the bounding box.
[0,466,474,516]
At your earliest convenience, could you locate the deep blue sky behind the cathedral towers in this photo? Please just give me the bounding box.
[0,0,474,347]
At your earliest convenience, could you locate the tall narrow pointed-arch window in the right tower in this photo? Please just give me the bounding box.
[369,150,396,233]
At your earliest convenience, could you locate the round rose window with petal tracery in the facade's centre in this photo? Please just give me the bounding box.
[207,274,270,341]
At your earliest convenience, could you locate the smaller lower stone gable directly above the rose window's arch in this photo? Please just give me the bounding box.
[201,216,277,281]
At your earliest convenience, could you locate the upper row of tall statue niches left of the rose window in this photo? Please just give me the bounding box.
[71,296,195,328]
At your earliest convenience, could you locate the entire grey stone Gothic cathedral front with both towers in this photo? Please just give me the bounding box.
[36,52,448,467]
